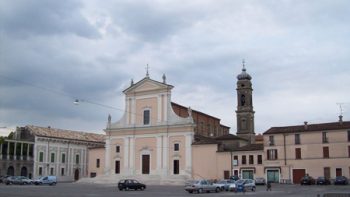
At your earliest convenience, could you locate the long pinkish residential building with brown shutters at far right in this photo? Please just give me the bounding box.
[264,116,350,183]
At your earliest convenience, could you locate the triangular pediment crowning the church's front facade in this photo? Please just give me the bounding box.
[123,77,173,94]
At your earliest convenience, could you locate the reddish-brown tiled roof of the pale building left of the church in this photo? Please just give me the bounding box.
[25,125,105,143]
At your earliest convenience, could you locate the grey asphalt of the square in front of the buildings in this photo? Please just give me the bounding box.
[0,183,350,197]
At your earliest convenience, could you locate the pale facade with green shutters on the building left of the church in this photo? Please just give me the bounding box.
[33,136,99,182]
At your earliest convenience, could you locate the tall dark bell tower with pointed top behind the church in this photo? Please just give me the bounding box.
[236,60,255,144]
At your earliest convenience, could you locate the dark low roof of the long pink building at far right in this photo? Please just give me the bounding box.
[264,121,350,135]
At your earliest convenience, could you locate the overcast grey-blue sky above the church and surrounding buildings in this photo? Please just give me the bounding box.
[0,0,350,134]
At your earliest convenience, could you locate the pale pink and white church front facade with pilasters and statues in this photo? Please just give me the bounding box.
[105,75,195,177]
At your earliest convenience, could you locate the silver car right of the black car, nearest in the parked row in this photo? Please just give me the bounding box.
[185,179,221,193]
